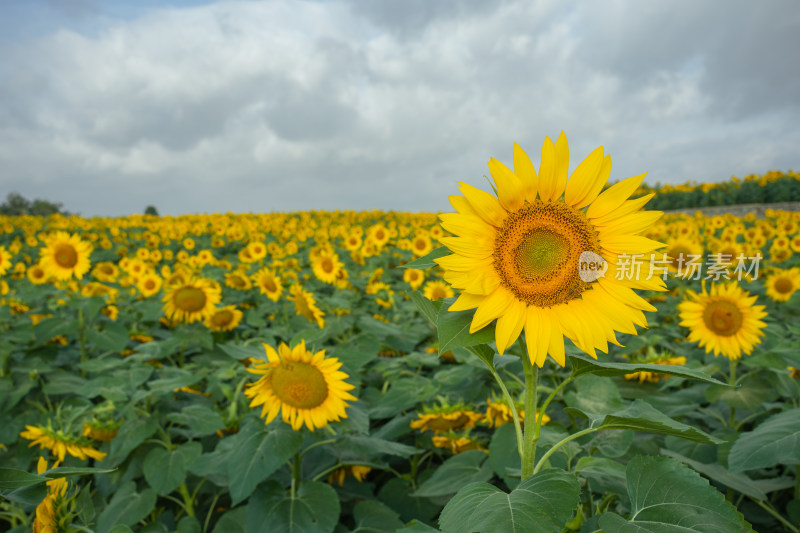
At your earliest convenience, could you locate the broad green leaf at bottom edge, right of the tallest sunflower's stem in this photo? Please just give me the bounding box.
[600,455,753,533]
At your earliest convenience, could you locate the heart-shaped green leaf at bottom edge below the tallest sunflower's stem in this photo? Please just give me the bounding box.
[439,470,581,533]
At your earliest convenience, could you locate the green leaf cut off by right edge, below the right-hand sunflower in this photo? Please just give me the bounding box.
[728,408,800,472]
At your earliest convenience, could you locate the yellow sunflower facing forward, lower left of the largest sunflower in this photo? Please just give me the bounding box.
[244,340,356,431]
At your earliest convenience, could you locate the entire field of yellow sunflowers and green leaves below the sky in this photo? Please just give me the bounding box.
[0,135,800,533]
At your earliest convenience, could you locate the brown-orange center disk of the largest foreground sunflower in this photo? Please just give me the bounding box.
[493,200,600,307]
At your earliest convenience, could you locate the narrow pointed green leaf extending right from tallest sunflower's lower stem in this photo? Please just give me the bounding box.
[564,400,722,444]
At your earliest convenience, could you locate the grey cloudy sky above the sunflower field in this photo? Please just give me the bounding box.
[0,0,800,216]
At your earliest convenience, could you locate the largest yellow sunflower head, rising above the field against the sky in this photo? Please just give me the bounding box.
[436,133,665,367]
